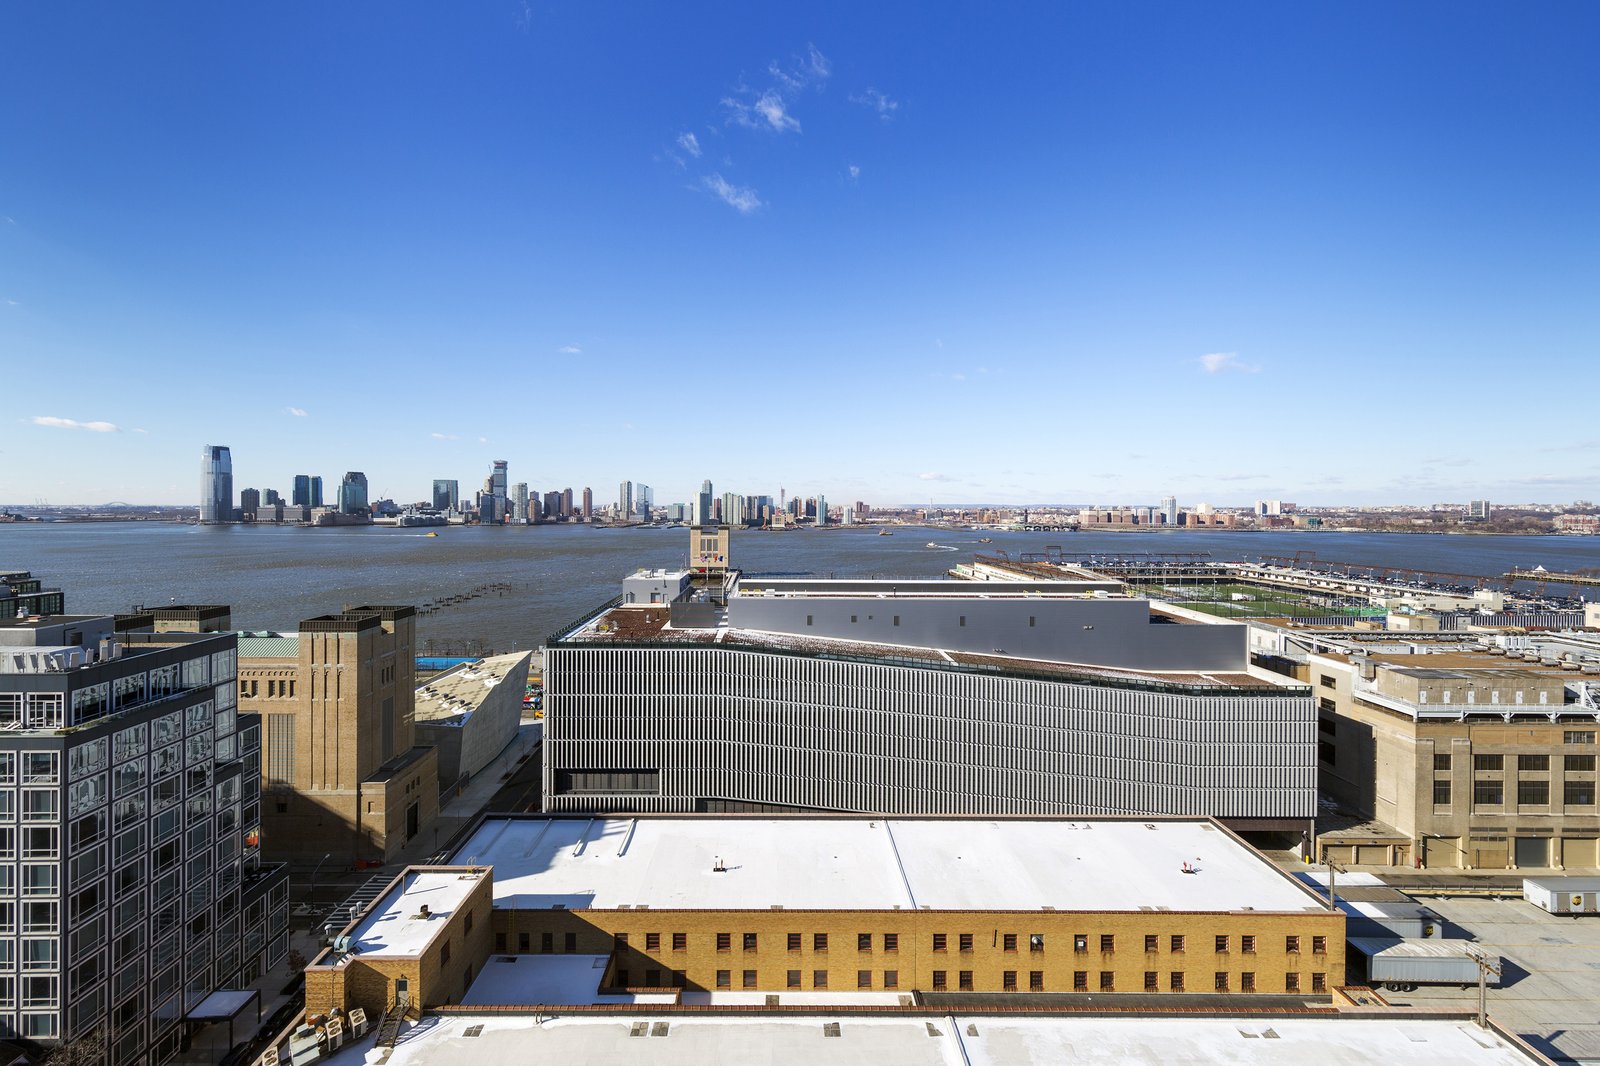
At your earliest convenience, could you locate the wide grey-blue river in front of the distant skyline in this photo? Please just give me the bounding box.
[0,522,1600,655]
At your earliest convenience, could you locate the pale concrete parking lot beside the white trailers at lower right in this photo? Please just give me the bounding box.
[1382,895,1600,1063]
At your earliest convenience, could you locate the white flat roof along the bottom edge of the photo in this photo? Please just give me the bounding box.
[315,1013,1536,1066]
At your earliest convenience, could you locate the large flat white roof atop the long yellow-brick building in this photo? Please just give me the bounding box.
[453,816,1323,911]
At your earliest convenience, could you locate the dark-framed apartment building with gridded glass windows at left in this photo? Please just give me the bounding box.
[0,615,288,1066]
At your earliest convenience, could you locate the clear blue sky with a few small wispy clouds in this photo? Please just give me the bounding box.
[0,0,1600,504]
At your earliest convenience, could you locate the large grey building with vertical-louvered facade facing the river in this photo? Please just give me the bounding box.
[544,576,1317,831]
